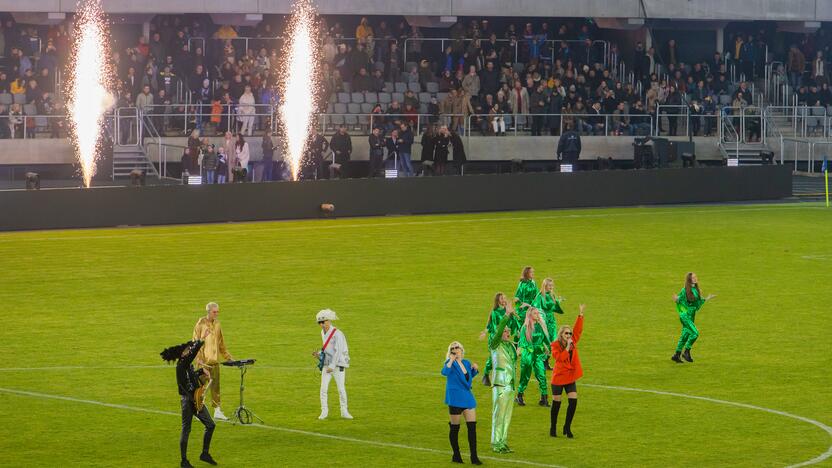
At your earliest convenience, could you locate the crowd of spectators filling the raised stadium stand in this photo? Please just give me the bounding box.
[8,15,832,144]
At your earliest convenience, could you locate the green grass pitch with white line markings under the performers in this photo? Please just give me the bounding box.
[0,204,832,467]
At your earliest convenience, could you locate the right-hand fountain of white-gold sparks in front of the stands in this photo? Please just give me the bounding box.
[280,0,319,180]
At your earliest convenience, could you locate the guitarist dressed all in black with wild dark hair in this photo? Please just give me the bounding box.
[160,331,217,468]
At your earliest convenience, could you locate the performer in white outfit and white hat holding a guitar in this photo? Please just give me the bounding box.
[312,309,352,419]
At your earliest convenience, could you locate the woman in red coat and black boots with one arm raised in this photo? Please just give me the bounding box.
[549,304,586,439]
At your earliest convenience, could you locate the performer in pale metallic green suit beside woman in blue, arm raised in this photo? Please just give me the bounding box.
[488,306,517,453]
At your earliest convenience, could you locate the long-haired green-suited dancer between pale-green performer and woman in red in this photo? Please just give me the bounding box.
[517,307,551,406]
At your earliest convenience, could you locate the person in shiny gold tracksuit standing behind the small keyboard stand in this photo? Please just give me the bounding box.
[193,302,234,420]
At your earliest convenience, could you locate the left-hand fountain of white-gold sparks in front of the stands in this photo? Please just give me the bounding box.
[67,0,112,187]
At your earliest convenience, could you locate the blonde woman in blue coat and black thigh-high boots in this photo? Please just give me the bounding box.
[442,341,482,465]
